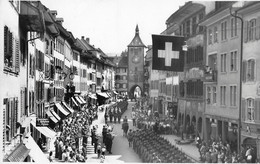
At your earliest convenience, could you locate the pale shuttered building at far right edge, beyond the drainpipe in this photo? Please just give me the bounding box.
[237,2,260,157]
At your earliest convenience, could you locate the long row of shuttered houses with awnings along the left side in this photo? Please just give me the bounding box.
[0,0,115,163]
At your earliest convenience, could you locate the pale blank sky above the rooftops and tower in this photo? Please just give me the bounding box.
[40,0,185,56]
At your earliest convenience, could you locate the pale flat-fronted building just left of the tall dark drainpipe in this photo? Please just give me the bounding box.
[201,2,241,150]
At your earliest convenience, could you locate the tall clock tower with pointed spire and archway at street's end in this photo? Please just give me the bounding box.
[127,25,146,98]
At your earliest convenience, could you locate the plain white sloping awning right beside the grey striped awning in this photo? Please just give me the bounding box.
[24,133,50,163]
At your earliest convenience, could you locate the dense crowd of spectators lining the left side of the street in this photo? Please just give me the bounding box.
[51,106,98,162]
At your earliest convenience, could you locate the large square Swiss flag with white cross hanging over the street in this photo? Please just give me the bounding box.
[152,35,184,72]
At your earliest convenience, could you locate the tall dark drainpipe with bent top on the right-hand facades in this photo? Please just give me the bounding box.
[229,2,244,153]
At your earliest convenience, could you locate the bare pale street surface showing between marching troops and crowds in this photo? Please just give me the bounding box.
[86,102,142,163]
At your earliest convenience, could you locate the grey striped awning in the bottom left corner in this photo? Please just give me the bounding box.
[7,143,30,162]
